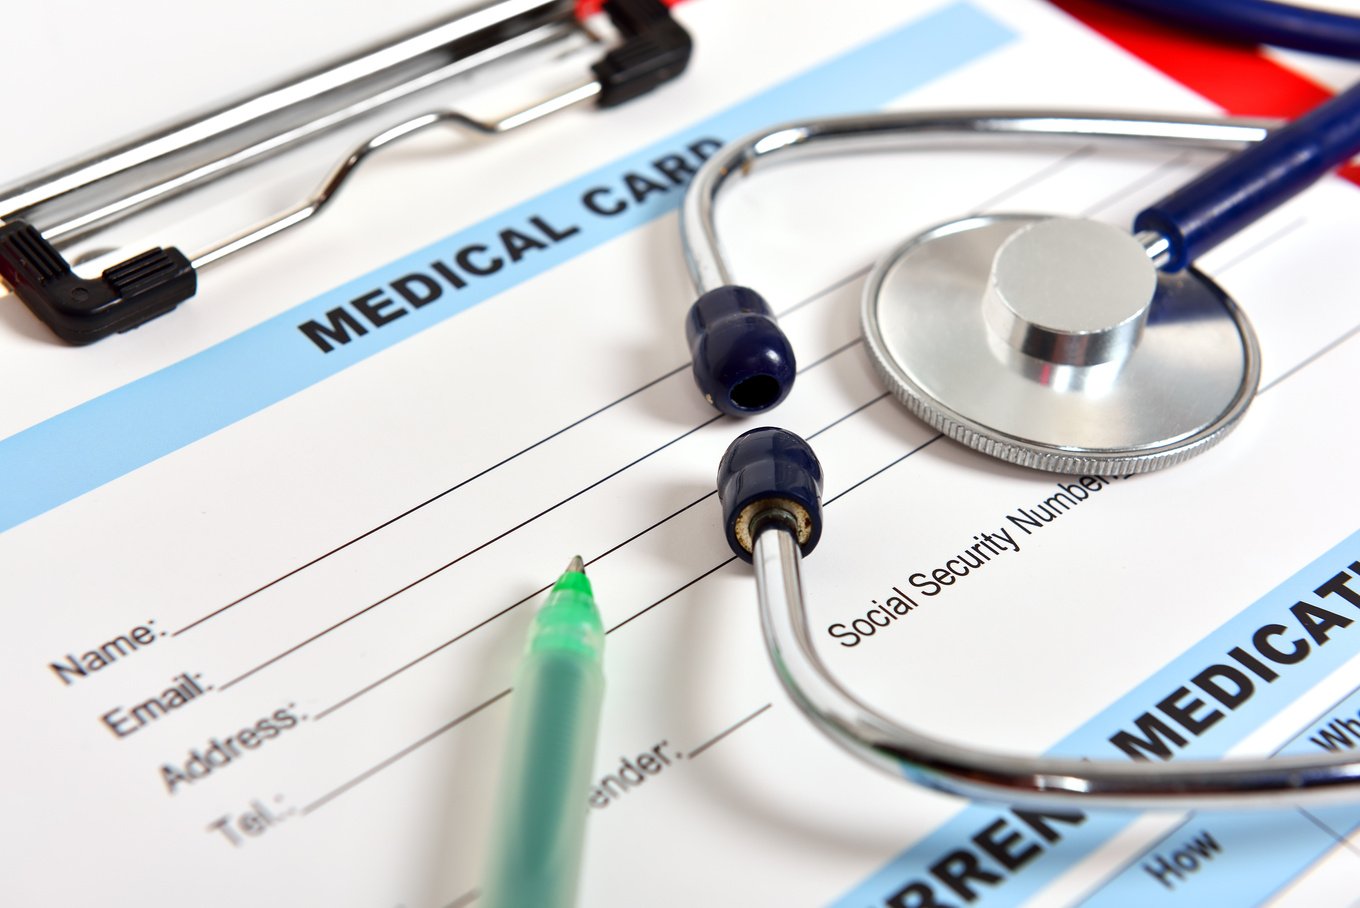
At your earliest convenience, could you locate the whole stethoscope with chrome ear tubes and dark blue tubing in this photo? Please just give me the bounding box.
[681,0,1360,809]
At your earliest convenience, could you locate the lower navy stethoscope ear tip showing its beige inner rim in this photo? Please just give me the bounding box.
[718,427,821,561]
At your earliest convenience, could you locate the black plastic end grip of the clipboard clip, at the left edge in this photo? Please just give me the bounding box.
[0,220,199,345]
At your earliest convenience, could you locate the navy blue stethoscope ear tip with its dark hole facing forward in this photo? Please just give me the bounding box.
[685,285,797,416]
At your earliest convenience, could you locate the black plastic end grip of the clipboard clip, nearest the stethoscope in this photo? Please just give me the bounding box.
[592,0,694,107]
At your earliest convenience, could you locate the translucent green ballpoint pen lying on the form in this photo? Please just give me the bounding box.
[480,555,604,908]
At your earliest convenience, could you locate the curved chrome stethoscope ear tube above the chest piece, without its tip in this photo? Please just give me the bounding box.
[680,110,1281,294]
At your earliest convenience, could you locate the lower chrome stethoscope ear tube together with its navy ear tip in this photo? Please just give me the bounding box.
[718,428,1360,810]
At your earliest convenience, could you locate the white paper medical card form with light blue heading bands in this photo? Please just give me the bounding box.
[0,0,1360,907]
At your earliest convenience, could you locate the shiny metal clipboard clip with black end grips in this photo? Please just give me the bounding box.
[0,0,691,344]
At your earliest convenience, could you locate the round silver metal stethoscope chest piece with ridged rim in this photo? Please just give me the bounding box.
[861,215,1261,473]
